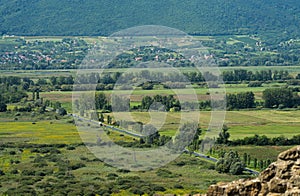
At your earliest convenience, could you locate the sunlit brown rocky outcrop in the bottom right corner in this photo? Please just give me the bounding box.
[207,146,300,196]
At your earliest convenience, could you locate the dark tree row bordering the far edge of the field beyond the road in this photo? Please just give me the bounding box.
[75,88,300,115]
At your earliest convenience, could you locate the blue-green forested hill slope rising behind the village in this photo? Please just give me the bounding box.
[0,0,300,37]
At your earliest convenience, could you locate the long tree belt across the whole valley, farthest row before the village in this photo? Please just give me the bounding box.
[0,69,300,95]
